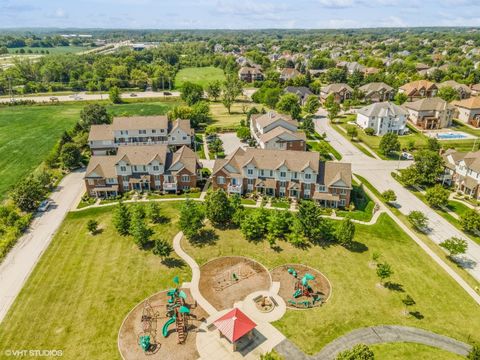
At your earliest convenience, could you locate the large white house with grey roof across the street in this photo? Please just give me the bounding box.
[357,102,408,136]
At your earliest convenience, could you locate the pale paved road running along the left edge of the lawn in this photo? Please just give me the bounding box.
[0,171,85,322]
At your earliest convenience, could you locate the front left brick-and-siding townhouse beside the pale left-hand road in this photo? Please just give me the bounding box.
[84,144,201,198]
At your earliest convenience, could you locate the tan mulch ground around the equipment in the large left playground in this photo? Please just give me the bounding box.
[118,289,207,360]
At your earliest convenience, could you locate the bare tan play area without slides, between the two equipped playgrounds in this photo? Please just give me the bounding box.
[199,256,272,311]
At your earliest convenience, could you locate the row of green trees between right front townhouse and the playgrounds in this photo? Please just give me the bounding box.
[180,189,355,248]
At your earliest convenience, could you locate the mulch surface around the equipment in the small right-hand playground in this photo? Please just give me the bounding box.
[270,264,331,308]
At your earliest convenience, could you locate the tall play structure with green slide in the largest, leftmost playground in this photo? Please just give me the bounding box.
[162,277,190,344]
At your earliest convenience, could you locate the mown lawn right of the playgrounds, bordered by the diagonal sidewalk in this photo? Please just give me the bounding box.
[183,215,480,359]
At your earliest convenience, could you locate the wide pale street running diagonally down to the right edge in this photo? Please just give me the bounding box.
[315,109,480,281]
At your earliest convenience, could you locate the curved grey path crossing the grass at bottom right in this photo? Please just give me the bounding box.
[316,325,472,360]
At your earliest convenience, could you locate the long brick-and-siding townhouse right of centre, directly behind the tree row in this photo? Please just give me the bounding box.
[212,148,352,208]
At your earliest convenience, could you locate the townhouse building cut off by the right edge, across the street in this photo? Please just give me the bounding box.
[440,149,480,199]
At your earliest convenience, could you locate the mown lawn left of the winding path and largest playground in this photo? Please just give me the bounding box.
[0,202,191,360]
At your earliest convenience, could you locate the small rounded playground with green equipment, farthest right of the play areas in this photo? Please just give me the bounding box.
[270,264,331,309]
